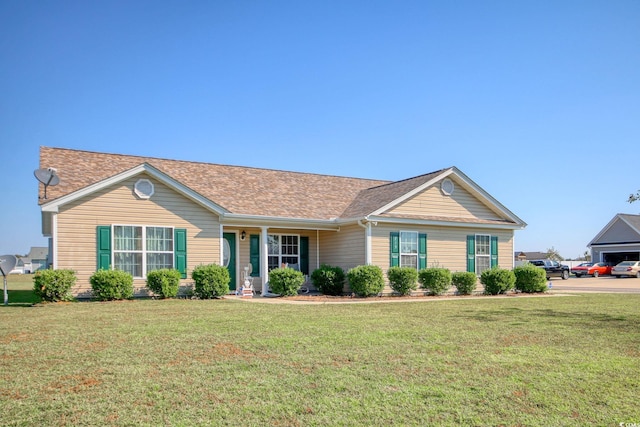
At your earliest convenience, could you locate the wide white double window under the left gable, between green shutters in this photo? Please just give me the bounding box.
[113,225,174,278]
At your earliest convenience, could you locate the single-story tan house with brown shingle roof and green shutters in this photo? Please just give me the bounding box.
[35,147,526,296]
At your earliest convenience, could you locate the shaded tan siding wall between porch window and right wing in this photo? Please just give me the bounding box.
[320,224,366,272]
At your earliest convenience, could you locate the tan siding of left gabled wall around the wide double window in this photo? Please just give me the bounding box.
[56,175,220,296]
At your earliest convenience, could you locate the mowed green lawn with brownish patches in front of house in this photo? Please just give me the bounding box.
[0,280,640,426]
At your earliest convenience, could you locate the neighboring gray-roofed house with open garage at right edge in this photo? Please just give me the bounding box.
[587,214,640,264]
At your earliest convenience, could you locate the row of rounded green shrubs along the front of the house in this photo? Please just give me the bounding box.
[34,264,547,301]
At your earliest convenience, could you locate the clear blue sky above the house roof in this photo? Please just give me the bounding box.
[0,0,640,258]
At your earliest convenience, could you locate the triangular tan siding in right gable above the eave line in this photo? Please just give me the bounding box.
[387,184,504,220]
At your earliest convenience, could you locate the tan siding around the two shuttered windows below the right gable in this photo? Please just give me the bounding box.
[372,225,513,292]
